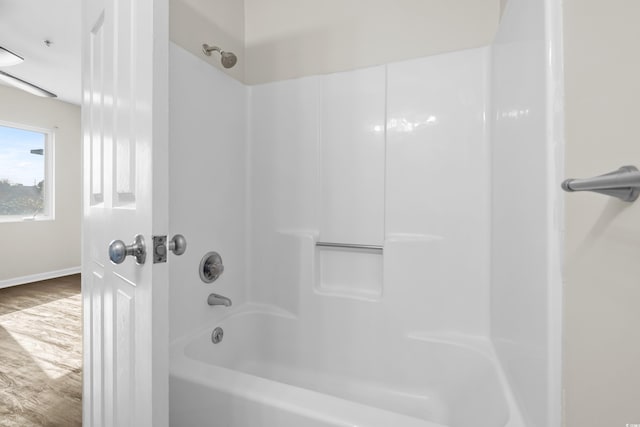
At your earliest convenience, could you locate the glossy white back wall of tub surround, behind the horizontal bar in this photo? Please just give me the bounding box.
[249,49,490,339]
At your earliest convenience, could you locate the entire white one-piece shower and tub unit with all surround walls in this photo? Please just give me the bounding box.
[169,0,562,427]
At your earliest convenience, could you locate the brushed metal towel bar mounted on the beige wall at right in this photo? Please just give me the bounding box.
[562,166,640,202]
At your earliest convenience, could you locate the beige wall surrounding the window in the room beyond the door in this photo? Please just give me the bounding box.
[0,85,82,287]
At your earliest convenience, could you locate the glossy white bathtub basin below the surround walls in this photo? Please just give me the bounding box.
[170,304,523,427]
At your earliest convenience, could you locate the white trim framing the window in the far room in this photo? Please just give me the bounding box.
[0,120,56,223]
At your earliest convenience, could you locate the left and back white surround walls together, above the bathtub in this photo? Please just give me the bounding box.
[170,40,489,339]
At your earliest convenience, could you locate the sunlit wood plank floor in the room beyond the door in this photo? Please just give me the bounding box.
[0,275,82,427]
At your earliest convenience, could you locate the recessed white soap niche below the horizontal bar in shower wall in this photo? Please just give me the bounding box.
[314,246,383,301]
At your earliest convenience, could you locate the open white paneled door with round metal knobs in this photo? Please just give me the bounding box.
[82,0,168,427]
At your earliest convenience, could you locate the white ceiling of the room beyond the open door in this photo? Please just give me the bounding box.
[0,0,81,104]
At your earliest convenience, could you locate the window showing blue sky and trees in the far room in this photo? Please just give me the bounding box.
[0,122,53,221]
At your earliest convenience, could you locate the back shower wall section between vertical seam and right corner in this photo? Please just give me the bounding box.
[385,48,491,336]
